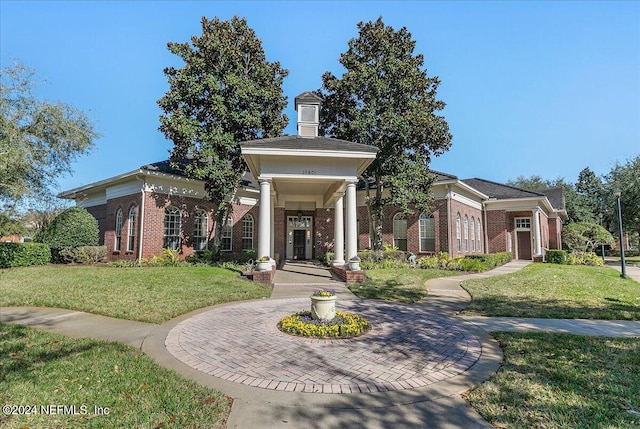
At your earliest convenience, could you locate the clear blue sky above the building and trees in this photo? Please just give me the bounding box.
[0,0,640,195]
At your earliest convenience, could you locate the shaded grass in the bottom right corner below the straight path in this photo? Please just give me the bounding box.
[466,332,640,429]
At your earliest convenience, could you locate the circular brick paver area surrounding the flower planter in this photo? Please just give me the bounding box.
[165,298,481,393]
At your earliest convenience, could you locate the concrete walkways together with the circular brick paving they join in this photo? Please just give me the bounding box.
[0,261,640,429]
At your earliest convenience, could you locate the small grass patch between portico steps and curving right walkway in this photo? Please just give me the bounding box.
[349,268,461,304]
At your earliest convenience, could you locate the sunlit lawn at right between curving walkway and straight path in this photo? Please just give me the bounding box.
[462,264,640,320]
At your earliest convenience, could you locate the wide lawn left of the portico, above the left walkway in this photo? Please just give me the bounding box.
[0,265,271,323]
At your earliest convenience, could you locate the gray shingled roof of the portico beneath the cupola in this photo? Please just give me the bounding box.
[240,136,378,153]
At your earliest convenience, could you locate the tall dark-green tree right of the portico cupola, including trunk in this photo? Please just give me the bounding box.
[318,18,451,250]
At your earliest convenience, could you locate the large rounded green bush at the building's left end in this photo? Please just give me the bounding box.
[42,207,98,261]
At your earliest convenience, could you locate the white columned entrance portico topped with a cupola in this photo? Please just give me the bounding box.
[241,92,378,265]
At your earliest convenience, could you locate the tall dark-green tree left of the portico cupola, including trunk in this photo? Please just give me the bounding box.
[158,17,288,256]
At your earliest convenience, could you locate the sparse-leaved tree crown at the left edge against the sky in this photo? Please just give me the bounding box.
[0,61,98,205]
